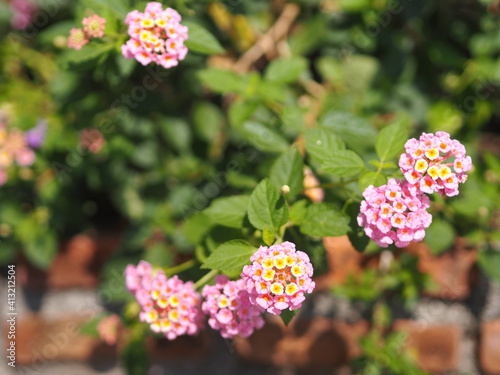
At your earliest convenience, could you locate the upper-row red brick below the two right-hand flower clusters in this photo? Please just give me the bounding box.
[407,241,477,300]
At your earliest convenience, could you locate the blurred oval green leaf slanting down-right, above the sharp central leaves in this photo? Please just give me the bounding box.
[241,121,289,152]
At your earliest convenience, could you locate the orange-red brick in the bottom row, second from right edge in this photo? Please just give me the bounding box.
[394,320,462,373]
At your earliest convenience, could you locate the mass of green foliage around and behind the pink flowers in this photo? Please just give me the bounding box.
[0,0,500,374]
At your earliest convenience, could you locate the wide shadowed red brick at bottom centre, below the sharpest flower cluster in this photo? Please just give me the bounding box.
[234,318,368,370]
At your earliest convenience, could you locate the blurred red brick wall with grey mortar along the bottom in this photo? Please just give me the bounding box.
[0,235,500,375]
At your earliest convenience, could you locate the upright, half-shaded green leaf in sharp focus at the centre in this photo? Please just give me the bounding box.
[248,178,288,233]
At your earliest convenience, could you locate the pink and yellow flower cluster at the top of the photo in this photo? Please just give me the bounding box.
[122,2,188,69]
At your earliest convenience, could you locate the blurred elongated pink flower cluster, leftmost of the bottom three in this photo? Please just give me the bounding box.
[125,261,203,340]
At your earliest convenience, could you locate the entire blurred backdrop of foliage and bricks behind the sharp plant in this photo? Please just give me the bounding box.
[0,0,500,375]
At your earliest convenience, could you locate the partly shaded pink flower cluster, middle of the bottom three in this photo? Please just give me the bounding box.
[201,275,265,338]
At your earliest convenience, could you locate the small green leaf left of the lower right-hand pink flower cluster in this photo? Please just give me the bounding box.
[300,203,350,237]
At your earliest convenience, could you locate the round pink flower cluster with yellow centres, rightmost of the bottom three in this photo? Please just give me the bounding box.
[241,242,315,315]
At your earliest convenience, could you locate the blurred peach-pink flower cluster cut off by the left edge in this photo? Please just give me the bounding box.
[0,113,42,186]
